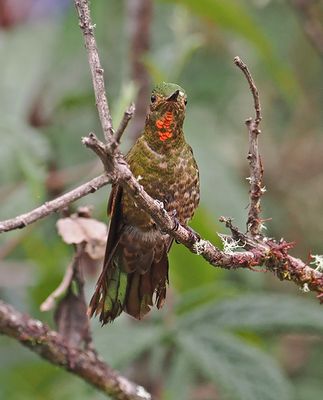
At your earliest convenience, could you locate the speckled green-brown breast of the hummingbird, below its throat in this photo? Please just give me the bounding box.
[122,141,199,231]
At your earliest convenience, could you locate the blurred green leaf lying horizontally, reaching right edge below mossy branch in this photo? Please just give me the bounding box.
[183,292,323,333]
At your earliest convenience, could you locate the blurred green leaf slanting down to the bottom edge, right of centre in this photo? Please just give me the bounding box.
[177,329,291,400]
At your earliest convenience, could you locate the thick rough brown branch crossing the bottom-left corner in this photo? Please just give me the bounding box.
[0,301,151,400]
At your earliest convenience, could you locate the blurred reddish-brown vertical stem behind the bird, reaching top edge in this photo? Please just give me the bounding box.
[127,0,153,139]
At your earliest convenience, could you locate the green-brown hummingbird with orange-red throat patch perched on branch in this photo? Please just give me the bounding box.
[89,82,200,325]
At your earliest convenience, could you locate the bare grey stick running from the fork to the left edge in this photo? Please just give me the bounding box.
[0,174,111,233]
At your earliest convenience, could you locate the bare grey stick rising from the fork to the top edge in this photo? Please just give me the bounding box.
[75,0,113,142]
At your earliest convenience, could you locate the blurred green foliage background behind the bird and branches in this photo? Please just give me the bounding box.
[0,0,323,400]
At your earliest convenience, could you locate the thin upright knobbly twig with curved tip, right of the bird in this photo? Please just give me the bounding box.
[234,57,265,236]
